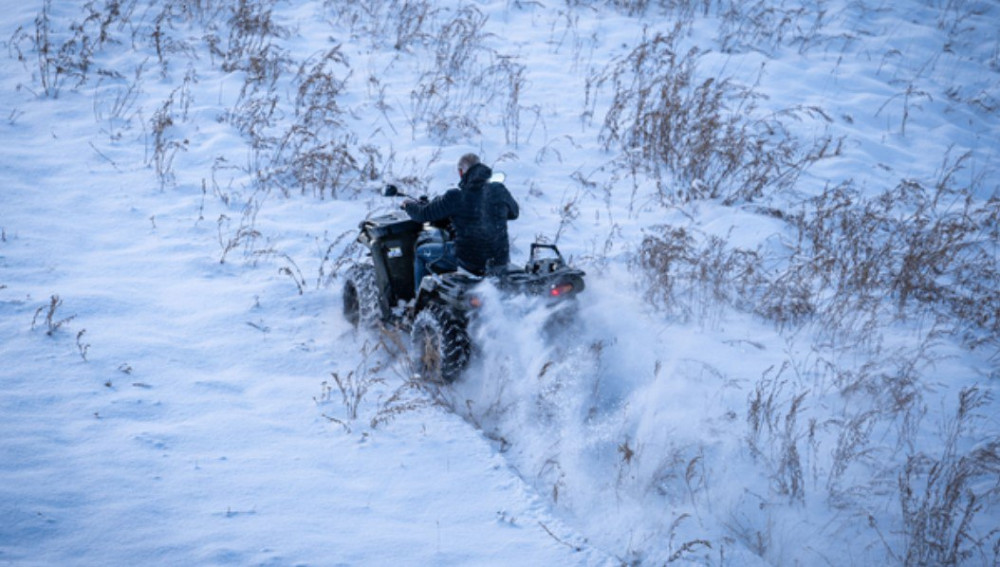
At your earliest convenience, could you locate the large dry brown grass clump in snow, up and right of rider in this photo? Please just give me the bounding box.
[591,21,840,211]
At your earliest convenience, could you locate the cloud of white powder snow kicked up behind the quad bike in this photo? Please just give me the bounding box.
[446,273,764,564]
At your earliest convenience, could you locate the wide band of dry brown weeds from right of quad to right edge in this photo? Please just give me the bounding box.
[636,148,1000,344]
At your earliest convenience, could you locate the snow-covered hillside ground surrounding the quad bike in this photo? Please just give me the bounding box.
[0,0,1000,565]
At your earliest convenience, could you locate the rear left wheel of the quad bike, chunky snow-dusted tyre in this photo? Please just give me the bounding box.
[410,303,470,383]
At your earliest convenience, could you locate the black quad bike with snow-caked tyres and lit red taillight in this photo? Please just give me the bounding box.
[343,185,585,383]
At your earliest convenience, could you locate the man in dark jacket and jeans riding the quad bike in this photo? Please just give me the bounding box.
[403,154,519,288]
